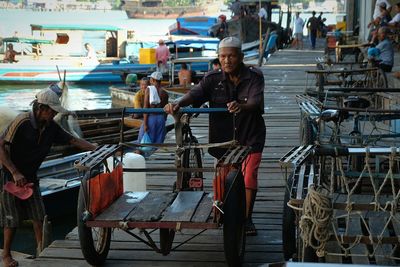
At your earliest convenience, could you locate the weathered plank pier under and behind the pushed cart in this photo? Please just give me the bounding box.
[31,50,322,267]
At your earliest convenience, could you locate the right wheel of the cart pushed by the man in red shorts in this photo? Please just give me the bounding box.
[223,170,246,266]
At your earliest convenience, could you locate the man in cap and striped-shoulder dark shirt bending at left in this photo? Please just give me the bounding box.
[0,88,96,266]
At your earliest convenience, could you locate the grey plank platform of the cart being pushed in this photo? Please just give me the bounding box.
[86,191,218,230]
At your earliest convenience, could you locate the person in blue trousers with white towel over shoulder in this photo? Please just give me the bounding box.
[138,71,168,152]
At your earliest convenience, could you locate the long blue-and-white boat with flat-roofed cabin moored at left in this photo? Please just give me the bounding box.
[0,24,156,84]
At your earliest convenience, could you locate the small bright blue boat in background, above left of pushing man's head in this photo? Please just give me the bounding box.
[169,16,218,36]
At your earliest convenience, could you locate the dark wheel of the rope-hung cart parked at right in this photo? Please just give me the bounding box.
[282,173,296,261]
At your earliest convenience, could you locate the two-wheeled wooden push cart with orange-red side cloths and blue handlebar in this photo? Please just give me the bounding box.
[76,108,249,266]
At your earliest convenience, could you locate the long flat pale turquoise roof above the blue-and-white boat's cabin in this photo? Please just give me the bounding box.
[31,24,122,31]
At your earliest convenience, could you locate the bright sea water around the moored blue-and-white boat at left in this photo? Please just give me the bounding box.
[0,9,174,110]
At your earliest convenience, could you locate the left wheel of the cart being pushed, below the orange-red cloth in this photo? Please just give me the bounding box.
[77,185,111,266]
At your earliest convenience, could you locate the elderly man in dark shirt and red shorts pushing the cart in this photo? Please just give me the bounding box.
[164,37,266,235]
